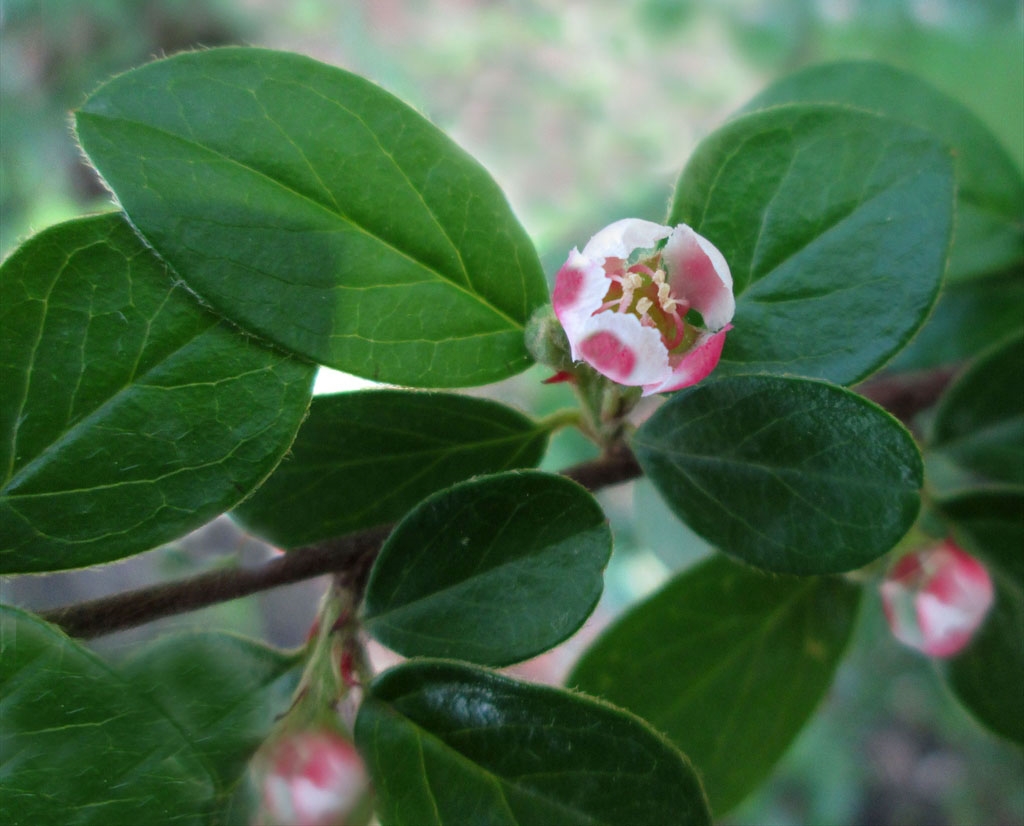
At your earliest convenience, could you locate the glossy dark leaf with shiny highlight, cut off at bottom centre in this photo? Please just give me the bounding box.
[355,660,710,826]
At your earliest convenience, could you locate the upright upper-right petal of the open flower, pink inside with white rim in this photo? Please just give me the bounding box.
[663,224,736,332]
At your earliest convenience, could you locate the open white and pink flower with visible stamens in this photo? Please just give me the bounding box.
[552,218,736,396]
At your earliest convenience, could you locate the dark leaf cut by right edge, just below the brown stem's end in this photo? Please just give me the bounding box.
[926,332,1024,493]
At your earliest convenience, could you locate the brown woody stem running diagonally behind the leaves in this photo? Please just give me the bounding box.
[37,367,954,638]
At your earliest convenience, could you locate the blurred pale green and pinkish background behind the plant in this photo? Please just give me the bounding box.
[0,0,1024,826]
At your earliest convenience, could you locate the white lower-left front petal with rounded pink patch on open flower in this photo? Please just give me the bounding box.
[573,312,672,387]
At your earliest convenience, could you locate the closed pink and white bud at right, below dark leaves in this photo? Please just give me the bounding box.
[882,540,993,657]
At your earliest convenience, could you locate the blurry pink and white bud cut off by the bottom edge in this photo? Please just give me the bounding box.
[257,730,369,826]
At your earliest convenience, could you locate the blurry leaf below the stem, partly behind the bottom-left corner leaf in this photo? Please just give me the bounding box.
[118,632,301,790]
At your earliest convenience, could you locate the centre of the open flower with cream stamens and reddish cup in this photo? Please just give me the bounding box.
[594,256,693,351]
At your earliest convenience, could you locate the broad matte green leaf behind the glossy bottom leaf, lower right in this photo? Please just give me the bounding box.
[567,555,860,816]
